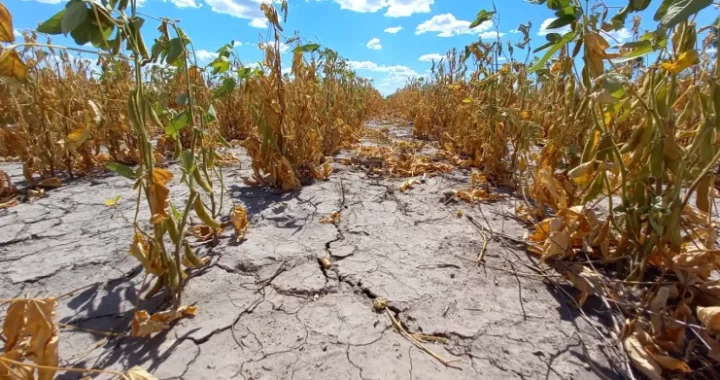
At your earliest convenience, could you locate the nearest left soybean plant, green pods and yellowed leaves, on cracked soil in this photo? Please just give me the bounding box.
[26,0,221,308]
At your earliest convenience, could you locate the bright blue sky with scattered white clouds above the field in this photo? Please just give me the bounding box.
[3,0,717,94]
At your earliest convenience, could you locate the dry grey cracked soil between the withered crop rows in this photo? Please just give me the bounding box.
[0,123,619,380]
